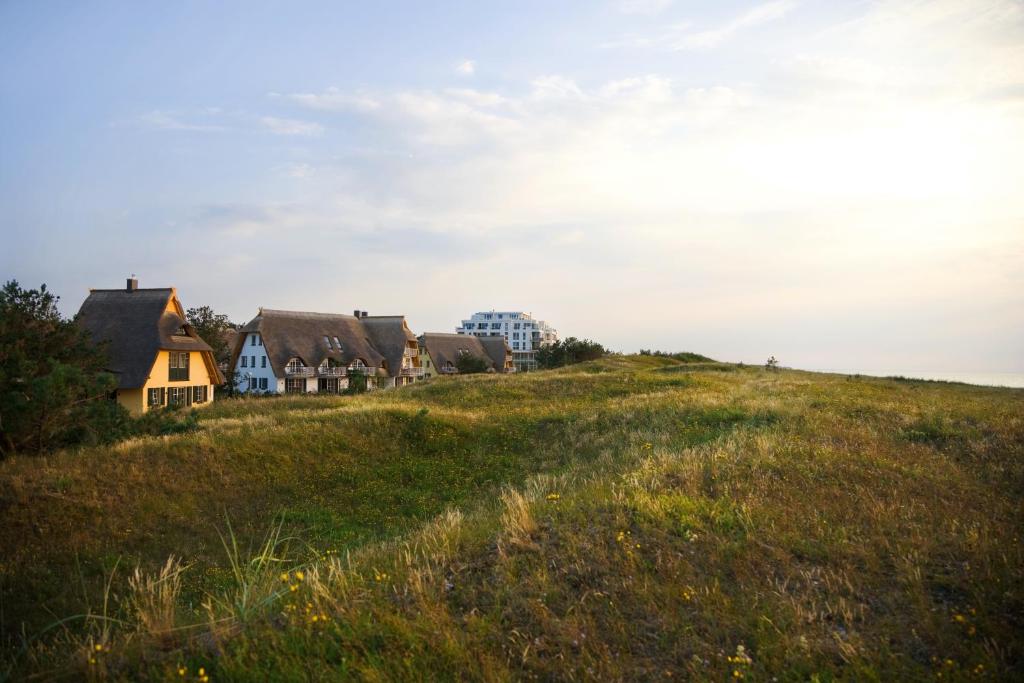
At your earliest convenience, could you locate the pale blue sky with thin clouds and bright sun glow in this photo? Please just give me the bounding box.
[0,0,1024,372]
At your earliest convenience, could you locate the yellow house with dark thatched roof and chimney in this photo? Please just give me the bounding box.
[76,278,224,415]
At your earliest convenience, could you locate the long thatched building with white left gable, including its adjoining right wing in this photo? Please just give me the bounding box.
[231,308,423,393]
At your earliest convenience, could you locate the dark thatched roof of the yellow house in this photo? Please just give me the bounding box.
[75,288,223,389]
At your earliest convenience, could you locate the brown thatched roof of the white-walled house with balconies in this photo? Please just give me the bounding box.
[231,308,385,377]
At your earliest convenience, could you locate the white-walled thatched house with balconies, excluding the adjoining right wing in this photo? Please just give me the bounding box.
[230,308,385,393]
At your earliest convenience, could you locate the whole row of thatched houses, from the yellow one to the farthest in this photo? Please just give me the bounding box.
[77,278,515,414]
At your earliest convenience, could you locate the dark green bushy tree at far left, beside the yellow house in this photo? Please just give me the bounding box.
[0,280,130,457]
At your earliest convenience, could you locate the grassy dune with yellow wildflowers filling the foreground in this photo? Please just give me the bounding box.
[0,356,1024,681]
